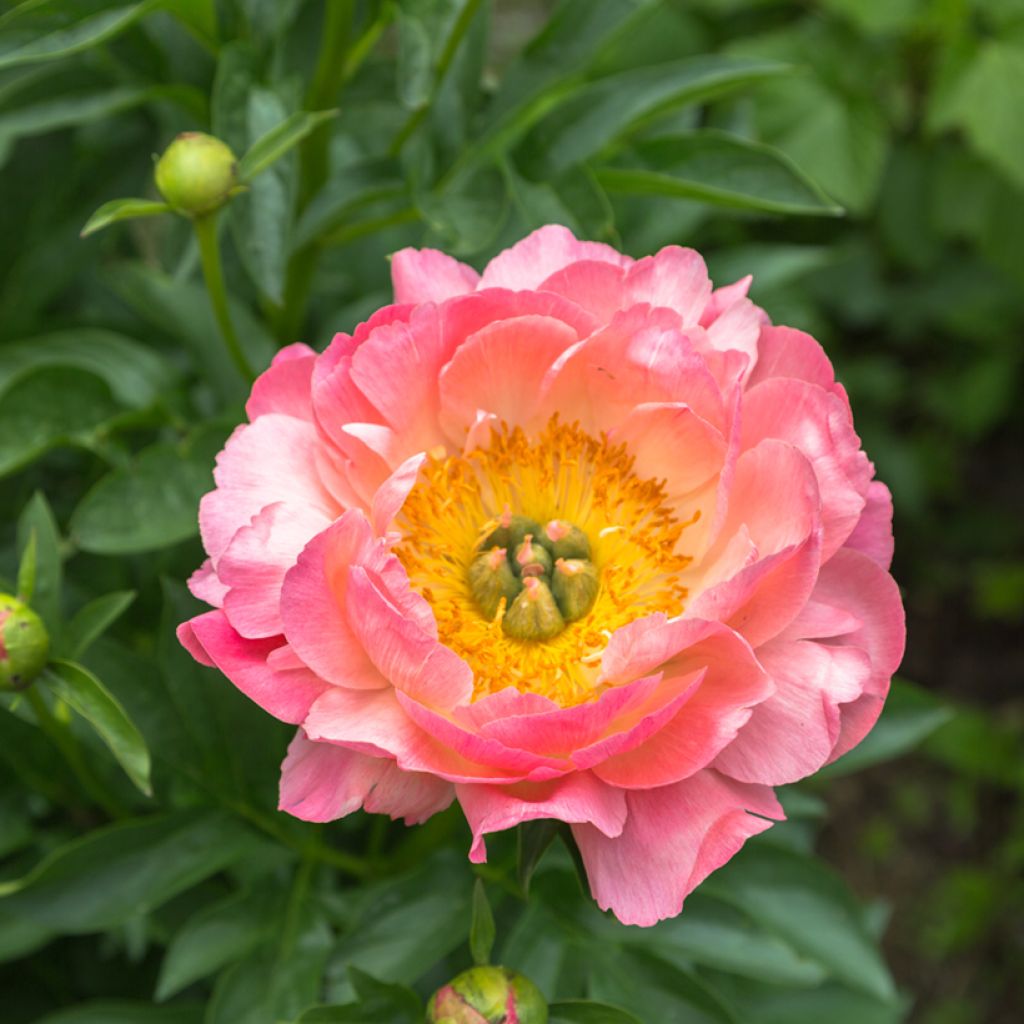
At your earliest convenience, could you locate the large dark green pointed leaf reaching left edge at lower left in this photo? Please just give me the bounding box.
[0,810,261,935]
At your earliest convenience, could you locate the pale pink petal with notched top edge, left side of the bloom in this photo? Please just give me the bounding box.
[217,502,331,639]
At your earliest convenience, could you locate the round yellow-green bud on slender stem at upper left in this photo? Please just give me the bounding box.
[157,131,239,217]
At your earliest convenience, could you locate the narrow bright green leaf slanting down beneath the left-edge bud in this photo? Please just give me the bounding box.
[43,660,153,797]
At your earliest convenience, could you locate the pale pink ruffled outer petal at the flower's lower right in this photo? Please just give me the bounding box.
[715,640,871,785]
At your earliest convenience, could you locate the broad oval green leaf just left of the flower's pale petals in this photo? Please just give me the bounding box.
[69,444,213,555]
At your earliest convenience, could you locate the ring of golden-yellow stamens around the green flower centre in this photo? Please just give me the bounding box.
[395,417,693,707]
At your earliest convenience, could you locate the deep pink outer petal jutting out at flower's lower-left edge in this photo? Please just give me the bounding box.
[178,610,329,725]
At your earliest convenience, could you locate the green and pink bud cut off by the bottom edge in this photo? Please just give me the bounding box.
[427,967,548,1024]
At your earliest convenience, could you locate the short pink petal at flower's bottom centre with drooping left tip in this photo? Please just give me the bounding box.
[456,772,626,864]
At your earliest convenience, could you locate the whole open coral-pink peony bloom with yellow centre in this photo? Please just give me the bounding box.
[178,226,904,925]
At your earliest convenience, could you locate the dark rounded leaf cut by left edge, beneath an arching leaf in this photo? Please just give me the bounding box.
[0,367,119,476]
